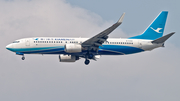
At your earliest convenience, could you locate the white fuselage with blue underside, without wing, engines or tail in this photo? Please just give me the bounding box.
[6,37,162,55]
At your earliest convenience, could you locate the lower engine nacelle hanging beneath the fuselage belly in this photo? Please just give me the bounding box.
[59,55,79,62]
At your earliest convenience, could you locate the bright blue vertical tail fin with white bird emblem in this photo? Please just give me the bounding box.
[129,11,168,40]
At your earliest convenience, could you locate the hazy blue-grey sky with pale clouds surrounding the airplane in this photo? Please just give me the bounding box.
[0,0,180,101]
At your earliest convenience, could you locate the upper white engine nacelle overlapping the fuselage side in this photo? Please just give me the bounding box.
[64,44,82,53]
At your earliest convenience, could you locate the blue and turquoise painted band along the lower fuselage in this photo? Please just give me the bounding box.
[9,45,144,55]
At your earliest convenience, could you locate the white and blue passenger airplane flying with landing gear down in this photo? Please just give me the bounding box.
[6,11,175,65]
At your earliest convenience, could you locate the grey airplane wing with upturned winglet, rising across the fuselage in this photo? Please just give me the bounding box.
[81,13,125,51]
